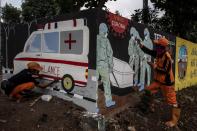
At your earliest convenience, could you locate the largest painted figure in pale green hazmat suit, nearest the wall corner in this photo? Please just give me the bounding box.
[97,23,115,107]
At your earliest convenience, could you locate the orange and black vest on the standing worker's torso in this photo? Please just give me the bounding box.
[154,52,174,86]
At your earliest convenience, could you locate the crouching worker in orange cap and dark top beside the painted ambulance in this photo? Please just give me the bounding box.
[1,62,57,102]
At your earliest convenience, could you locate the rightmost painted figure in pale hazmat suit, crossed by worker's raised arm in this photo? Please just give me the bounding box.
[140,28,153,90]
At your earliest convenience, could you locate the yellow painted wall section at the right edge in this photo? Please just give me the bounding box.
[175,37,197,90]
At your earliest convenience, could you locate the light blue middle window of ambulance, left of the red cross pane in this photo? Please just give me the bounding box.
[43,32,59,53]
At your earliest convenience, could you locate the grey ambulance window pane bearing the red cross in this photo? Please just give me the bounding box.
[60,30,83,54]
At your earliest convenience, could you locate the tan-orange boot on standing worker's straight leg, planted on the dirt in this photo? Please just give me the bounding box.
[165,107,181,127]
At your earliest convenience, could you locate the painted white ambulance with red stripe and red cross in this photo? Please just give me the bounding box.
[14,19,89,92]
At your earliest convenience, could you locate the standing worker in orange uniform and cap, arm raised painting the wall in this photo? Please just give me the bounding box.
[137,38,181,127]
